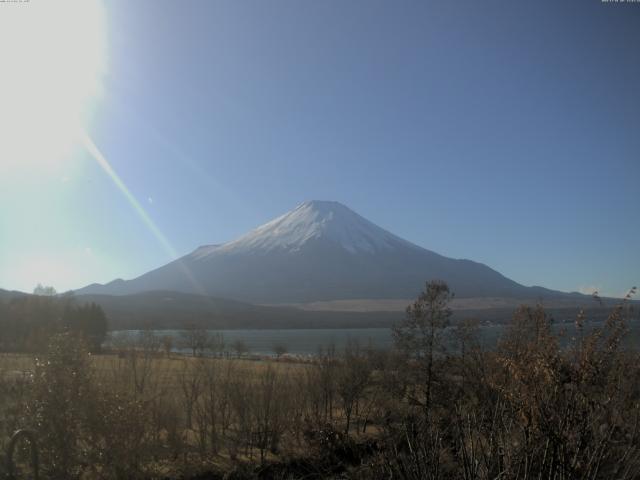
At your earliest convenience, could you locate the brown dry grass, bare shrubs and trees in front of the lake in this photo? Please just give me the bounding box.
[0,282,640,479]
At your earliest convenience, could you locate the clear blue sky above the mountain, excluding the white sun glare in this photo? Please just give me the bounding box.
[0,0,640,295]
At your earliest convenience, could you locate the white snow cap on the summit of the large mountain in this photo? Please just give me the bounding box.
[194,200,411,258]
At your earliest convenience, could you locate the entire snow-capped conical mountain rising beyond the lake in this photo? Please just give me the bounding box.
[76,201,570,304]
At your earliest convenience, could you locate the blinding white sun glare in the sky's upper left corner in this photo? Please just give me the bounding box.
[0,0,106,172]
